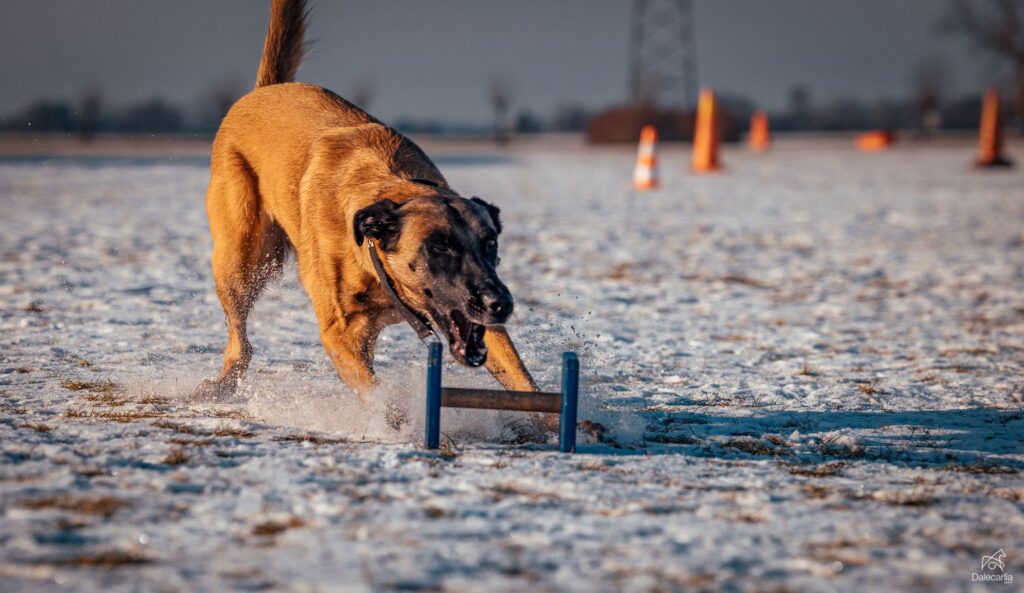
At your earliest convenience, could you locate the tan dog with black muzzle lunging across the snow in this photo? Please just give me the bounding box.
[198,0,537,413]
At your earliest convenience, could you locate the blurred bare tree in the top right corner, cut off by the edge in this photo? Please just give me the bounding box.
[940,0,1024,128]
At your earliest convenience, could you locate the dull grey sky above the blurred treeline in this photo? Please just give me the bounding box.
[0,0,994,123]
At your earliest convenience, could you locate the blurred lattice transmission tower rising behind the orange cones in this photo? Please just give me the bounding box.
[629,0,697,109]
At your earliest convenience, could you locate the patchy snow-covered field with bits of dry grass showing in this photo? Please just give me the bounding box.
[0,140,1024,593]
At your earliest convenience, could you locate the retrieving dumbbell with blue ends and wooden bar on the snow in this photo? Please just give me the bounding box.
[425,342,580,453]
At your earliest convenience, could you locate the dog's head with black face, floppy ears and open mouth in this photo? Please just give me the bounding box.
[352,190,512,367]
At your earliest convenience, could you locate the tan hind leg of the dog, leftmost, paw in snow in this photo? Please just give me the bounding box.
[196,155,288,398]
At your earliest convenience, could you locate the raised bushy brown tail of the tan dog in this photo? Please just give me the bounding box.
[256,0,308,88]
